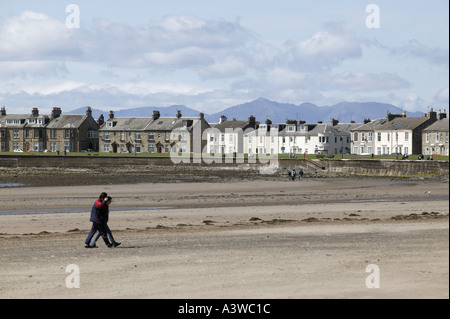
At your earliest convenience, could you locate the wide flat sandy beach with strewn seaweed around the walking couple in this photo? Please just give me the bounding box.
[0,178,449,299]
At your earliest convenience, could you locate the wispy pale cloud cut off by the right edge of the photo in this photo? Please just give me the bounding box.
[391,39,449,67]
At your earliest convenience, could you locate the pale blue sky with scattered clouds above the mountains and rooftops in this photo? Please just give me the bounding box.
[0,0,449,114]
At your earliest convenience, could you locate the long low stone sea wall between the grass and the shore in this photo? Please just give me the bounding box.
[0,155,449,177]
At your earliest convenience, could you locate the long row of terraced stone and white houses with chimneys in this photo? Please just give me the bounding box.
[0,107,449,156]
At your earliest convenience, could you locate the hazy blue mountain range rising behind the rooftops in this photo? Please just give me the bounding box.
[68,98,424,123]
